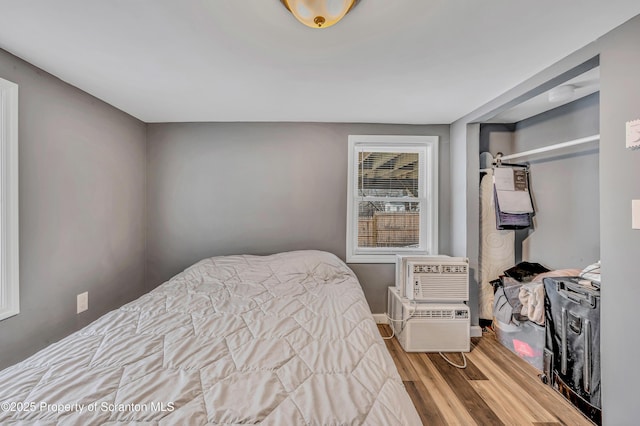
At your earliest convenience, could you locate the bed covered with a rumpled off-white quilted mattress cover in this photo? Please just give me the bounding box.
[0,251,421,425]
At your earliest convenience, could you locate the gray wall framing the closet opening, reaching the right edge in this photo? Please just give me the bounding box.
[451,16,640,426]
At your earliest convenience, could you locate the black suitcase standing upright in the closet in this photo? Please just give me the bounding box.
[543,277,602,425]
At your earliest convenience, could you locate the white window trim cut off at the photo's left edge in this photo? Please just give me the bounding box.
[0,78,20,320]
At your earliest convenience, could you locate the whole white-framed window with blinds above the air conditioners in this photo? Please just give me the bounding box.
[347,135,438,263]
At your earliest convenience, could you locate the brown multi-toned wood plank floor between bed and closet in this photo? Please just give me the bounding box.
[378,324,593,426]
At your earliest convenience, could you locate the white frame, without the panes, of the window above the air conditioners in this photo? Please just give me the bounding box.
[347,135,438,263]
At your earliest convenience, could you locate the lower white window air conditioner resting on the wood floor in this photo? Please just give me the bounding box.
[387,287,471,352]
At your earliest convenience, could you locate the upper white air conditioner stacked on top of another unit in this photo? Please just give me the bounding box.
[396,255,469,302]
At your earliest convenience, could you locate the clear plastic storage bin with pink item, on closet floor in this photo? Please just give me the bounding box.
[493,320,545,371]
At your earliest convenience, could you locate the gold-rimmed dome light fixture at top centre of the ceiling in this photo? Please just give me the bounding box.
[280,0,360,28]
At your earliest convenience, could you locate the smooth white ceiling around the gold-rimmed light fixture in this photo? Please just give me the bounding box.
[0,0,640,124]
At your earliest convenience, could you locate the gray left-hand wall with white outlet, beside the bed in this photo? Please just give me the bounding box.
[0,50,146,368]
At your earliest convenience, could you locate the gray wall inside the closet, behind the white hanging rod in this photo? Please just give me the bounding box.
[480,93,600,269]
